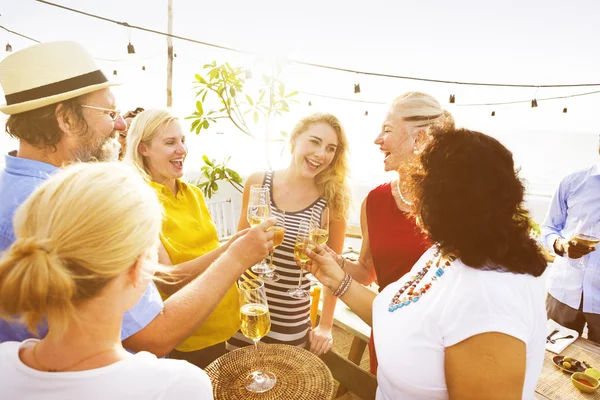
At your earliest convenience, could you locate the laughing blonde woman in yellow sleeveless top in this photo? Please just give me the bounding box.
[126,109,239,368]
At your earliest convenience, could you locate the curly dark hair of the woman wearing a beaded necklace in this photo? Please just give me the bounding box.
[400,127,547,276]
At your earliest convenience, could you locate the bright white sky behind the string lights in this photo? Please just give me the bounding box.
[0,0,600,206]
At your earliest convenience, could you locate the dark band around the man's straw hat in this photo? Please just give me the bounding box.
[4,70,108,106]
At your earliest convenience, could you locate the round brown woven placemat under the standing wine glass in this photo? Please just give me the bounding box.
[204,344,333,400]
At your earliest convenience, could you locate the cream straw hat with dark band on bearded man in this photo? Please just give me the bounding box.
[0,42,118,115]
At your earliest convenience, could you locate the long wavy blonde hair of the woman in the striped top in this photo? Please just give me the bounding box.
[290,113,350,219]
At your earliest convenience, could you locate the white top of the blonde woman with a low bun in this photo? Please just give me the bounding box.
[0,340,213,400]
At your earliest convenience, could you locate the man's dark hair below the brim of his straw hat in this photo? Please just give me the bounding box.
[5,95,88,151]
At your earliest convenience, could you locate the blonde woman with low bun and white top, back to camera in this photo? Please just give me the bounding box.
[0,163,213,400]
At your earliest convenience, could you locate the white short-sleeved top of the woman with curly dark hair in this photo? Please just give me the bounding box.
[373,247,546,400]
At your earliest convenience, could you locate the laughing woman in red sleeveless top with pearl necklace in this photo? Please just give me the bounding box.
[330,92,454,374]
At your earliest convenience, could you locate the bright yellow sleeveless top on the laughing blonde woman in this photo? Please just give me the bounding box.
[150,179,240,352]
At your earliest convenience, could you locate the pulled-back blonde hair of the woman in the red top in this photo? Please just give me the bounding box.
[392,92,454,132]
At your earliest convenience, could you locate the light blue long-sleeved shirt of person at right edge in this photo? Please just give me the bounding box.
[541,165,600,314]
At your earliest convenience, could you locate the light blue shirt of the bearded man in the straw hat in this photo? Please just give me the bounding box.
[0,156,163,343]
